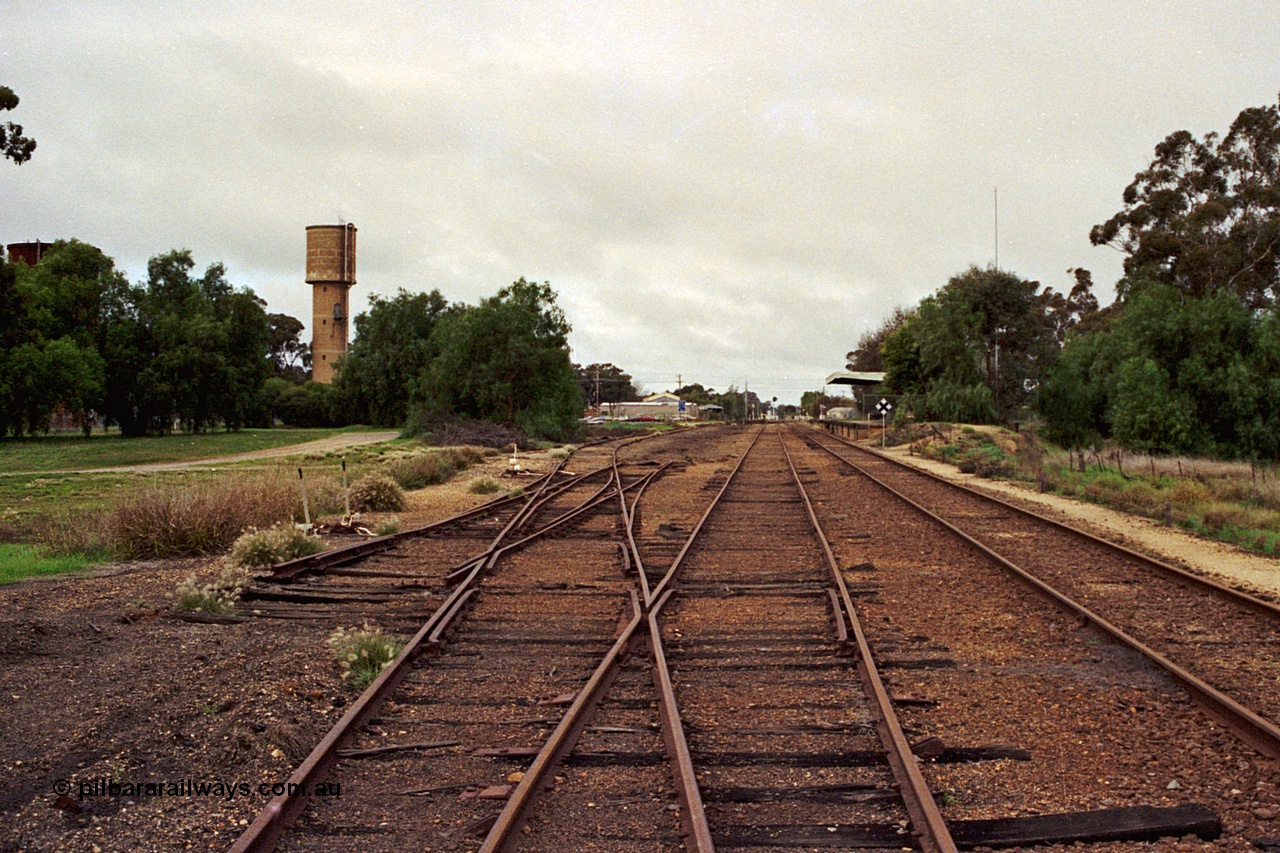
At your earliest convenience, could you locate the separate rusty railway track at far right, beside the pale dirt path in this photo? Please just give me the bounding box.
[800,430,1280,758]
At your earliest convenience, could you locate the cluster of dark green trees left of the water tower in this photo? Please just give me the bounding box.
[0,240,302,437]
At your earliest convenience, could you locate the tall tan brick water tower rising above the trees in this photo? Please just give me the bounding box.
[307,223,356,384]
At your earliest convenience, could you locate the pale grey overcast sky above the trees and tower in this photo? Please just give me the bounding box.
[0,0,1280,402]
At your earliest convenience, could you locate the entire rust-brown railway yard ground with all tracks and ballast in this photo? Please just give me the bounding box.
[0,424,1280,853]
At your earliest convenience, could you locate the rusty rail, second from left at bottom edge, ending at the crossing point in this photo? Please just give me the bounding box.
[479,589,644,853]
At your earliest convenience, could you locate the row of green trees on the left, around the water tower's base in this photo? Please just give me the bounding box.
[0,240,582,438]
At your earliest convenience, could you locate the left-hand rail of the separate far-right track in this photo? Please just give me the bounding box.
[793,425,1280,758]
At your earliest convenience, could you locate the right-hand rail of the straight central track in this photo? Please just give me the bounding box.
[778,432,956,853]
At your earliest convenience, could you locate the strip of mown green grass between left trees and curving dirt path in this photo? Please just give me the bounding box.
[0,427,381,474]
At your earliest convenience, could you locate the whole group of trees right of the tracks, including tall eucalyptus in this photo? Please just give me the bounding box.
[870,94,1280,459]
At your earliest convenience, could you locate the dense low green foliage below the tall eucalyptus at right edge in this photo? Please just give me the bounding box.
[1039,282,1280,459]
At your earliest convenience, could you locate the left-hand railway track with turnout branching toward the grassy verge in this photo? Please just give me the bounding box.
[233,425,757,850]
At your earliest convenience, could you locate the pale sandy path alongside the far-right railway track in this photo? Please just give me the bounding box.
[877,444,1280,596]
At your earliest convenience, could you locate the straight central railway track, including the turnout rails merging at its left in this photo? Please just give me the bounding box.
[481,425,955,853]
